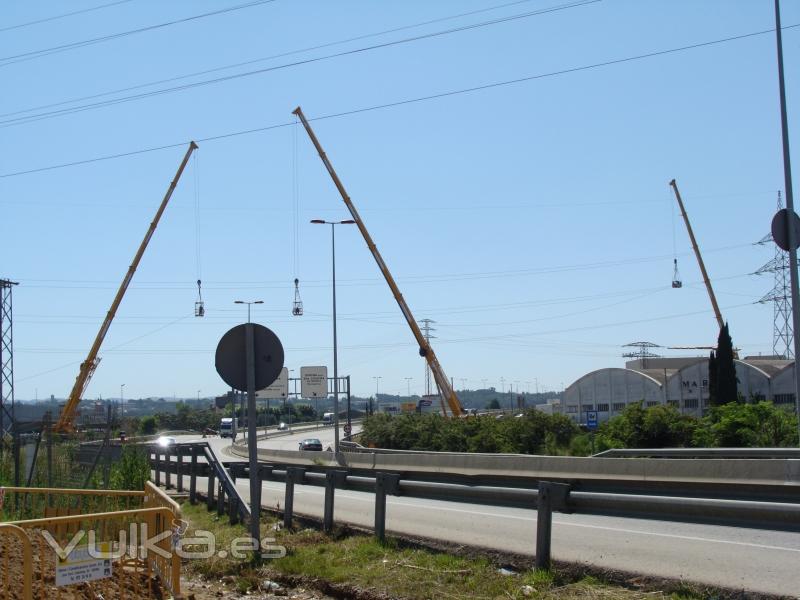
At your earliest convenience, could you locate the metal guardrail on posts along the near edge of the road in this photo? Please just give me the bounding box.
[147,444,800,568]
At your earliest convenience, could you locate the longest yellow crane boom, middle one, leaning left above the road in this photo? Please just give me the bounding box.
[292,106,464,417]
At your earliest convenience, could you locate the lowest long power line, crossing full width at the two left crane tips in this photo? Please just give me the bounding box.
[0,24,800,179]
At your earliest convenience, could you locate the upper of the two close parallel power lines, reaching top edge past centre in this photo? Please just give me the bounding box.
[0,0,544,117]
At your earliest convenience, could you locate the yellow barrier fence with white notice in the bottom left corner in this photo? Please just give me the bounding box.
[0,483,182,600]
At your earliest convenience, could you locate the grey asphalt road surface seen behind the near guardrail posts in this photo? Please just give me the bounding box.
[161,428,800,597]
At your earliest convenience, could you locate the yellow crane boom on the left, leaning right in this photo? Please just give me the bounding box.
[53,142,197,432]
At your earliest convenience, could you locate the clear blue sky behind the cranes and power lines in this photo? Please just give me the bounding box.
[0,0,800,399]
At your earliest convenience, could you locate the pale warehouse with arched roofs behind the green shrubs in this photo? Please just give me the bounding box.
[552,356,795,423]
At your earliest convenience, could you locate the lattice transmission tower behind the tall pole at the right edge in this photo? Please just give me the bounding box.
[755,192,794,359]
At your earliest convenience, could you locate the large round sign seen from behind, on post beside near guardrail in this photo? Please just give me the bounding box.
[214,323,283,392]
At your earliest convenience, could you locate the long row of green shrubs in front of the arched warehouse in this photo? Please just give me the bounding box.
[359,401,798,456]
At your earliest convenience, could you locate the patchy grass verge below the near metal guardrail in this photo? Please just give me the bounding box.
[183,504,700,600]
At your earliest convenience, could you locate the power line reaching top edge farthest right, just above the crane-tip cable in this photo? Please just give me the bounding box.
[0,0,602,127]
